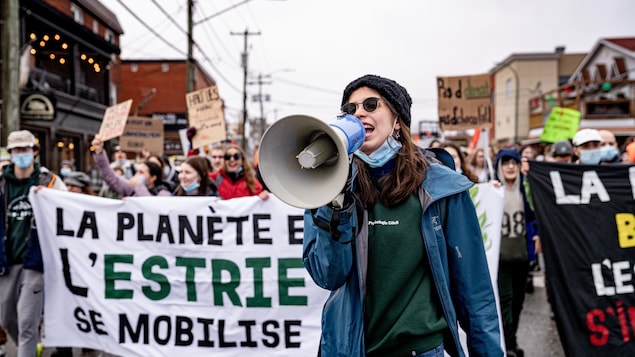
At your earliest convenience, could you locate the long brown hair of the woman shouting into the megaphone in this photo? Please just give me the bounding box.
[354,110,428,207]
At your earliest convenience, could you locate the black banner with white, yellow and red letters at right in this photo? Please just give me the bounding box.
[528,162,635,356]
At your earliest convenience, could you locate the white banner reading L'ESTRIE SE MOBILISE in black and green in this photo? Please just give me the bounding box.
[29,189,328,356]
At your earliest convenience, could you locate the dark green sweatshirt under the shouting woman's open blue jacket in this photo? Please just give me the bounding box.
[364,195,448,357]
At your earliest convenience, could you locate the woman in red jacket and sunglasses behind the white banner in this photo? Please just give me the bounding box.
[210,145,269,200]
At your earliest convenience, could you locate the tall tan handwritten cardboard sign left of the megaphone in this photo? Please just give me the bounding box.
[186,86,227,148]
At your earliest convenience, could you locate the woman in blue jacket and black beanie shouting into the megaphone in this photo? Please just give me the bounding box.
[302,75,503,357]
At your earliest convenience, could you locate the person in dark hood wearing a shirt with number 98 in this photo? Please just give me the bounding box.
[495,148,538,357]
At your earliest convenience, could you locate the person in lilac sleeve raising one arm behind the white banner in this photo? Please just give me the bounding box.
[91,134,172,197]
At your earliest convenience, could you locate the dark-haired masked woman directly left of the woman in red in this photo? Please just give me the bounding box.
[173,155,216,196]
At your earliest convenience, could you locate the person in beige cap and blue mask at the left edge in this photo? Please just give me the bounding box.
[0,130,66,356]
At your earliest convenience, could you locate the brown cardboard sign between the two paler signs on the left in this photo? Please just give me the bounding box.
[119,117,163,154]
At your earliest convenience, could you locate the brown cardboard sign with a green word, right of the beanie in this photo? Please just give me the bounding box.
[437,74,492,130]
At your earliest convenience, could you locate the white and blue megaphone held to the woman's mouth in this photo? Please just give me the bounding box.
[258,114,366,208]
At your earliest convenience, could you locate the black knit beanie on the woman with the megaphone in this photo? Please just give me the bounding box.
[342,74,412,128]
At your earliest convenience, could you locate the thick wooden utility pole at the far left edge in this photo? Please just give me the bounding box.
[0,0,22,146]
